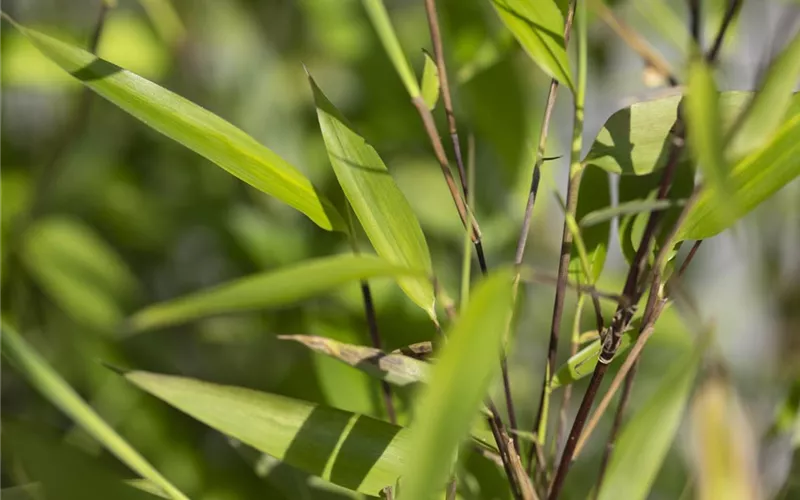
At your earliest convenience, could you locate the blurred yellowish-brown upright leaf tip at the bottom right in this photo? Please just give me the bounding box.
[690,378,762,500]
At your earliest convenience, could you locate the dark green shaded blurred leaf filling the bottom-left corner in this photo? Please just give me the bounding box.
[0,421,164,500]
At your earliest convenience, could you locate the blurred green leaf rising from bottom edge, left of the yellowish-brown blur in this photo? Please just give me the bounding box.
[598,346,702,500]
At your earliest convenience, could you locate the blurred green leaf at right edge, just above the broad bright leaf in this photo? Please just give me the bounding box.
[729,33,800,157]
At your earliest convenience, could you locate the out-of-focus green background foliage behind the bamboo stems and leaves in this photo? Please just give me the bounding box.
[0,0,800,500]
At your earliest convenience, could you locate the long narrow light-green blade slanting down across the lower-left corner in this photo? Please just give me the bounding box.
[0,319,188,500]
